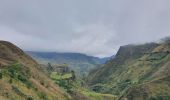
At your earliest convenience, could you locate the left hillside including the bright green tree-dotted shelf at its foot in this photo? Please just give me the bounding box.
[0,41,116,100]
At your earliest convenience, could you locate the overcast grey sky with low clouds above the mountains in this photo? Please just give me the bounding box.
[0,0,170,57]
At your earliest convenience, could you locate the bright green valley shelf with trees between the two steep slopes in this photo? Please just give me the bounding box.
[41,57,116,100]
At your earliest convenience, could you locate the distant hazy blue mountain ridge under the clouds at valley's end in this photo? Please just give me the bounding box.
[26,51,110,76]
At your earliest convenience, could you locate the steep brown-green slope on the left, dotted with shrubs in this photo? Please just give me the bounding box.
[0,41,70,100]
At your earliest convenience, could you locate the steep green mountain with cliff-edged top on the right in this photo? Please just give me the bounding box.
[88,39,170,100]
